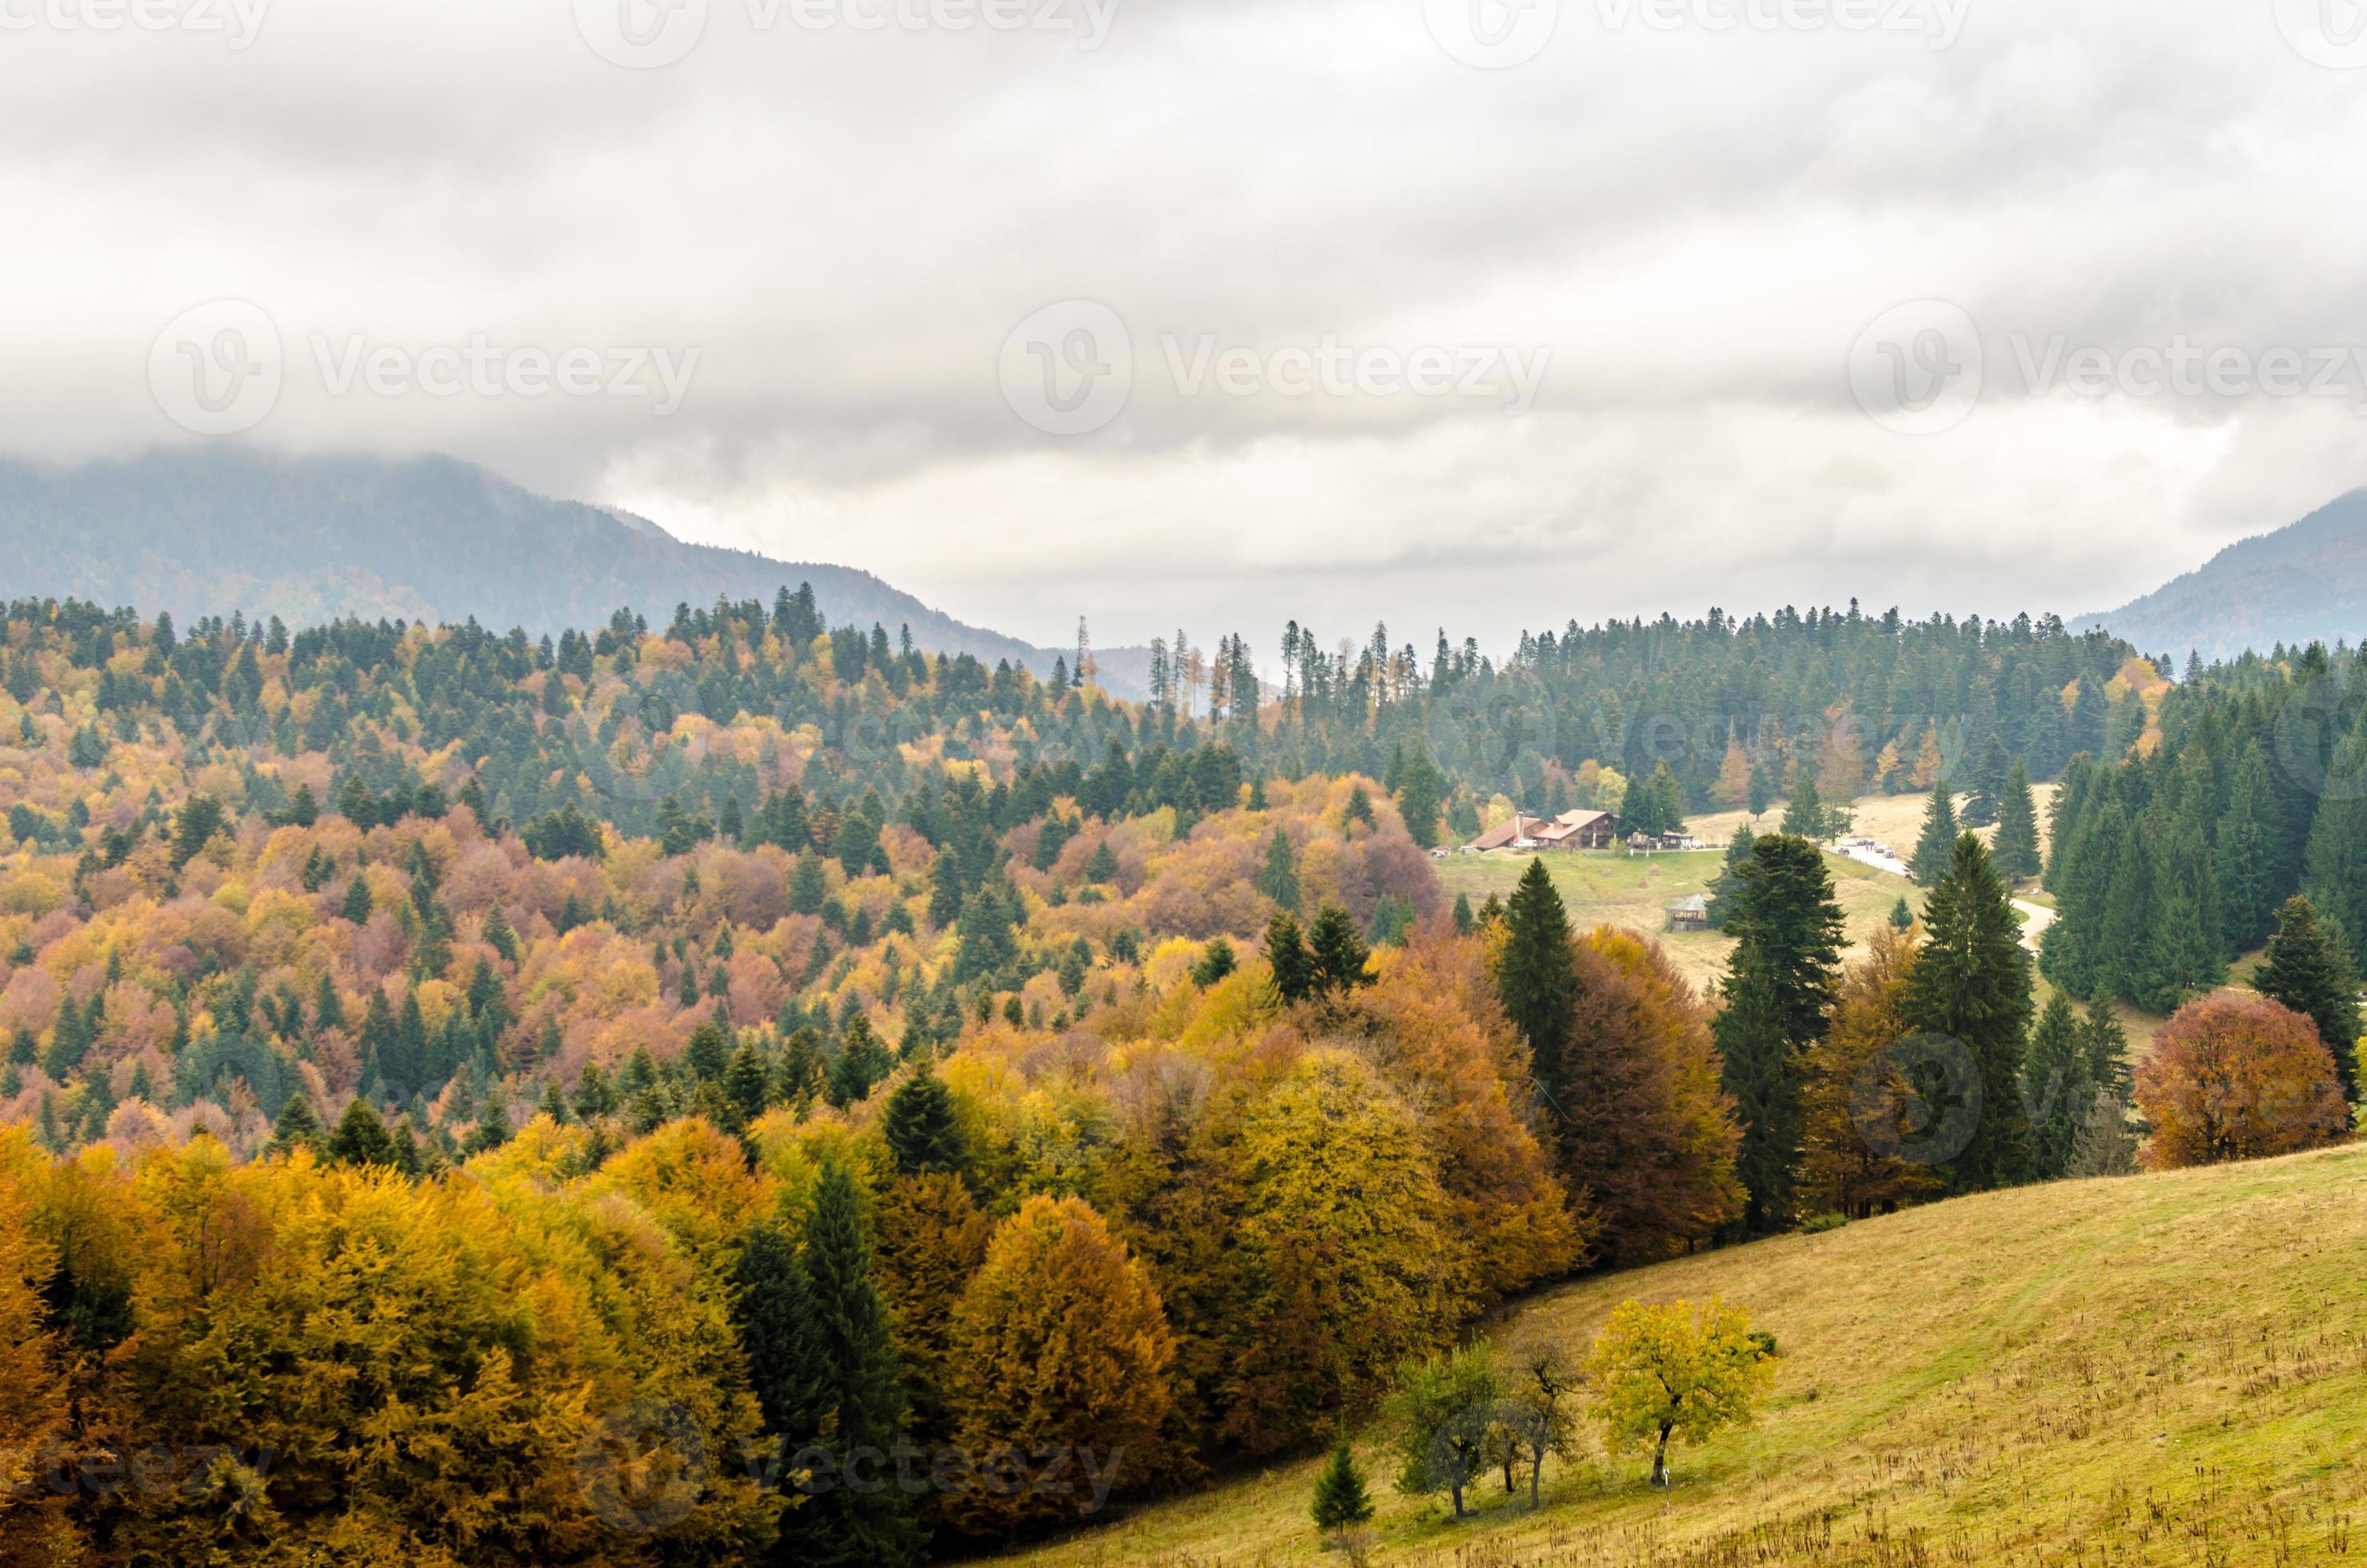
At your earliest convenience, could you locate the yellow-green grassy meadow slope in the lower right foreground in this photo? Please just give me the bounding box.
[975,1146,2367,1568]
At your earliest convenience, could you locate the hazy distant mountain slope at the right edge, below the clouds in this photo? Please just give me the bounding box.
[2076,490,2367,658]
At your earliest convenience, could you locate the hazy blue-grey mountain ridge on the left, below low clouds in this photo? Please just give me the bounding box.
[0,448,1141,696]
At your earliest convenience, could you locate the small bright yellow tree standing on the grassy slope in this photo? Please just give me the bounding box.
[1586,1296,1775,1487]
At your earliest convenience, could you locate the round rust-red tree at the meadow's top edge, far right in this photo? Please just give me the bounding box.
[2135,993,2350,1170]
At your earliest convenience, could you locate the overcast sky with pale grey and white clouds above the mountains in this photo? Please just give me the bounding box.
[0,0,2367,658]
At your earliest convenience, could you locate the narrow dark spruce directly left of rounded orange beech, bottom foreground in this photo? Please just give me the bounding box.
[790,1161,926,1568]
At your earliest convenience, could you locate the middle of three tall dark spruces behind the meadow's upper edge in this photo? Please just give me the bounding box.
[1716,834,1841,1234]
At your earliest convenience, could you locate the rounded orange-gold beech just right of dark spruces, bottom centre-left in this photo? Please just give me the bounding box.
[950,1196,1174,1528]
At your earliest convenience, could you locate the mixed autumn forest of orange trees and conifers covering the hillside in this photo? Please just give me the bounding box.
[0,590,2291,1566]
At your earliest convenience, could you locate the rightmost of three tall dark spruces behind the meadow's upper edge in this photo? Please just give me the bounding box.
[1901,834,2031,1191]
